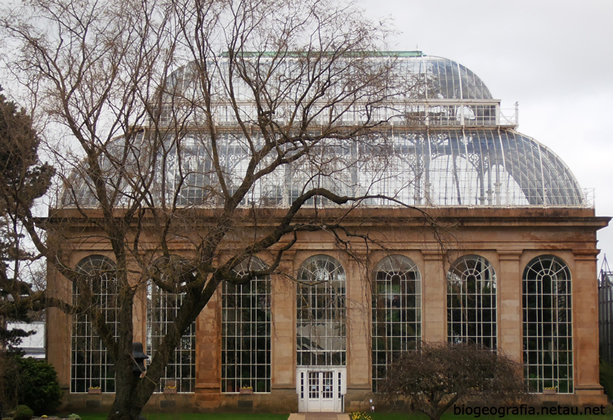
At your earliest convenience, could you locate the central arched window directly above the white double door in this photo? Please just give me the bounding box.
[296,255,347,366]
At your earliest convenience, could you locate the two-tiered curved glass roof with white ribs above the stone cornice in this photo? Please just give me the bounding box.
[64,52,588,207]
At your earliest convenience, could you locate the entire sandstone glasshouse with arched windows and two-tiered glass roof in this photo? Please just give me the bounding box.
[47,51,609,412]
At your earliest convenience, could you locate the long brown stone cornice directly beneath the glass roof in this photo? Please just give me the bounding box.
[45,207,611,230]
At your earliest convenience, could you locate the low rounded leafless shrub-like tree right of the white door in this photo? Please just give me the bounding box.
[378,343,528,420]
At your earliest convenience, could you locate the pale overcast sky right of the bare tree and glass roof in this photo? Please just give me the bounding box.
[358,0,613,270]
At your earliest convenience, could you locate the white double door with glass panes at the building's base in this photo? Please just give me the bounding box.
[296,366,347,413]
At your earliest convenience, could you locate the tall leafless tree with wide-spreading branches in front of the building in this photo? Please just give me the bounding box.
[2,0,420,419]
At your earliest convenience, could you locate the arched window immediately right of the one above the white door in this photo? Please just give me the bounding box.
[372,255,421,392]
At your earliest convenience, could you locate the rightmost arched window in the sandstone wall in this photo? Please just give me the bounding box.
[523,255,573,393]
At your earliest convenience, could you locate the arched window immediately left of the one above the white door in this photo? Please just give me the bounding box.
[221,257,271,392]
